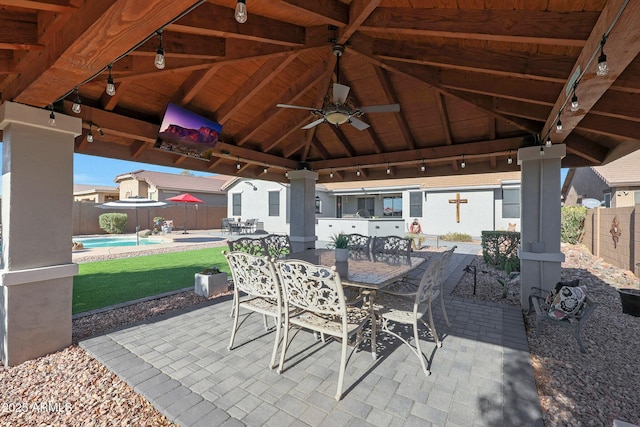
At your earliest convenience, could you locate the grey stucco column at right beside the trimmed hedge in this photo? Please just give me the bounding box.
[518,144,566,308]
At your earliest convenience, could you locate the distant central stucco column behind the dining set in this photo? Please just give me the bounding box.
[289,169,318,252]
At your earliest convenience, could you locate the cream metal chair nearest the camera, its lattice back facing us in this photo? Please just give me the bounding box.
[275,260,376,400]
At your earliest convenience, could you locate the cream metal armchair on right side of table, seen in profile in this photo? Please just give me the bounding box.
[374,256,444,376]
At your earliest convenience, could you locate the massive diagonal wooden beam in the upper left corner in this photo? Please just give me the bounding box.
[2,0,200,107]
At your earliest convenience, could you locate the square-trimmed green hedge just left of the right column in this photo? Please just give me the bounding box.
[482,231,520,273]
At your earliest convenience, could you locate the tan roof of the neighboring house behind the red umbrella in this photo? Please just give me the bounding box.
[115,170,234,193]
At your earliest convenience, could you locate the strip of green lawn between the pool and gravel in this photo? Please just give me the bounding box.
[72,246,230,314]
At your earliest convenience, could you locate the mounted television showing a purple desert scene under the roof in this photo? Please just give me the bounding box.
[154,103,222,160]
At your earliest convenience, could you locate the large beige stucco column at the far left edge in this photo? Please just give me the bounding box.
[0,102,82,366]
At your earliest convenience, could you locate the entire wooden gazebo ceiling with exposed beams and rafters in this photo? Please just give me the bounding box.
[0,0,640,182]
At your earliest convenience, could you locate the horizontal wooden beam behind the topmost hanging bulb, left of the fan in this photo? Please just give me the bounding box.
[167,3,305,46]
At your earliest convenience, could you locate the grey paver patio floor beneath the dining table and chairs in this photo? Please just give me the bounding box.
[80,239,543,427]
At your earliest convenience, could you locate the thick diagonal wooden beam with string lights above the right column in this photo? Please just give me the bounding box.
[541,0,640,142]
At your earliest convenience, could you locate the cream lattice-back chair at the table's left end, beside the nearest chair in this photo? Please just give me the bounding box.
[224,252,283,369]
